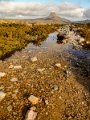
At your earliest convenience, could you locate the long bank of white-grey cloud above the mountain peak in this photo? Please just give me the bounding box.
[0,1,86,18]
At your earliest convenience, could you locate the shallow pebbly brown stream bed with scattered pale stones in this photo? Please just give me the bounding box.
[0,29,90,120]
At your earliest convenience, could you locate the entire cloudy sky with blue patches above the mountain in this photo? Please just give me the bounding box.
[0,0,90,21]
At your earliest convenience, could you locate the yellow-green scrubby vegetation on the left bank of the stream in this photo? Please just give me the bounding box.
[0,23,59,59]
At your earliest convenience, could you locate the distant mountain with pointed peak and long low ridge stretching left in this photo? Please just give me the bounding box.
[0,12,71,25]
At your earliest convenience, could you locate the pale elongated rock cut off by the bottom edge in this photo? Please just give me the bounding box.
[25,108,37,120]
